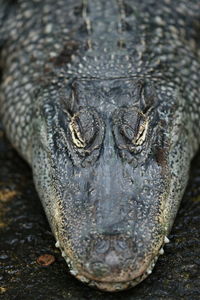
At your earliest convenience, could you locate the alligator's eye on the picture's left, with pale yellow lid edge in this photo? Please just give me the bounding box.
[69,109,98,148]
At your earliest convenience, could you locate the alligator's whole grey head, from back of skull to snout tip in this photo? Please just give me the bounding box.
[32,78,192,291]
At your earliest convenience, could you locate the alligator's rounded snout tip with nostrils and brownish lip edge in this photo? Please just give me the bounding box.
[65,238,162,292]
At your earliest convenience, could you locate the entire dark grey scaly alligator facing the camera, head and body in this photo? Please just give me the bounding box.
[0,0,200,291]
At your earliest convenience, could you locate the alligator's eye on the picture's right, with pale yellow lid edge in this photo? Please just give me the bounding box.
[113,107,148,152]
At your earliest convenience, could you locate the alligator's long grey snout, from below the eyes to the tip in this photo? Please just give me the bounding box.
[54,128,164,291]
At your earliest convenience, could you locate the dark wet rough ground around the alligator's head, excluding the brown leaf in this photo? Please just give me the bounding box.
[0,120,200,300]
